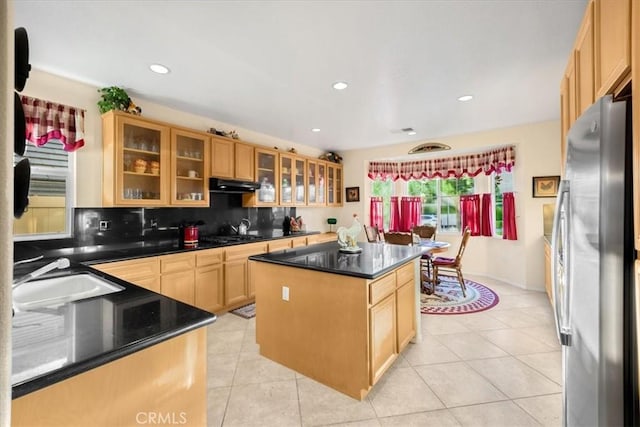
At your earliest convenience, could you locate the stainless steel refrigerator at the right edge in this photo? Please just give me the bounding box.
[552,95,638,426]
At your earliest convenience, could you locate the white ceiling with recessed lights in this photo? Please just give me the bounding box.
[14,0,587,152]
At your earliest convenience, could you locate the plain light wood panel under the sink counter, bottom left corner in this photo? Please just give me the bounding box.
[11,328,207,427]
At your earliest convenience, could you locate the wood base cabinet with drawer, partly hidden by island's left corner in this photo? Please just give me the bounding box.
[224,242,267,306]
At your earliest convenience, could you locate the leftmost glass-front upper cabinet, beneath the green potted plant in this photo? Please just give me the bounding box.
[102,111,170,207]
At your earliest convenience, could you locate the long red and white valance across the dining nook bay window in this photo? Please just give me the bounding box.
[368,145,516,181]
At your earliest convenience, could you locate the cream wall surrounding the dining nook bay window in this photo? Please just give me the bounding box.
[339,121,560,290]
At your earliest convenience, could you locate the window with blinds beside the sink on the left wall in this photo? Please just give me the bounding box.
[13,141,75,240]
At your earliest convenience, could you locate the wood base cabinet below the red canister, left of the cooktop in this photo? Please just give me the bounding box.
[159,253,196,305]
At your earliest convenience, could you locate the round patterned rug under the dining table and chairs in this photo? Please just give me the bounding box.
[420,276,500,314]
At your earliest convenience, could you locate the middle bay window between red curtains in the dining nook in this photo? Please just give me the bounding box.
[407,177,475,231]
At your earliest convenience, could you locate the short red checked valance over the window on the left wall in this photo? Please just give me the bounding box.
[21,95,84,151]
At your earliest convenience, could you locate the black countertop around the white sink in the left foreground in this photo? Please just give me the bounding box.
[11,265,216,399]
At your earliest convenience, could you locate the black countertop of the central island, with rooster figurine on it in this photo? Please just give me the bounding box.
[249,242,423,279]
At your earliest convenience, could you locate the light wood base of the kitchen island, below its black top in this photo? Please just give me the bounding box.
[249,260,416,400]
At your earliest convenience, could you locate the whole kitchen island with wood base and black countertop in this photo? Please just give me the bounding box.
[249,242,422,399]
